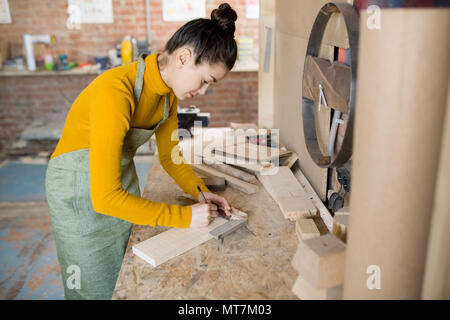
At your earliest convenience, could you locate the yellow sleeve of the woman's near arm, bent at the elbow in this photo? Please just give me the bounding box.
[89,81,192,228]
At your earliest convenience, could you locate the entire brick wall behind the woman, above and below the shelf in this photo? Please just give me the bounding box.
[0,0,258,151]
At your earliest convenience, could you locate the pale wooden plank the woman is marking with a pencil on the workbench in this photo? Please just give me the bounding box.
[133,217,228,267]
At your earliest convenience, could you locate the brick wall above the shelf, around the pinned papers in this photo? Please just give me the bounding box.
[0,0,258,62]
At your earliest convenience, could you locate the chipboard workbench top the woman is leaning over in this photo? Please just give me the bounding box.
[113,156,298,300]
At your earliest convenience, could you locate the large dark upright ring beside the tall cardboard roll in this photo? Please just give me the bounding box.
[302,2,359,168]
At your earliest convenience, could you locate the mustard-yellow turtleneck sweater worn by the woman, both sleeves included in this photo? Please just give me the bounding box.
[51,54,209,228]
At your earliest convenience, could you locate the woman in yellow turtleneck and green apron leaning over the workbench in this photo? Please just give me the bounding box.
[46,4,237,299]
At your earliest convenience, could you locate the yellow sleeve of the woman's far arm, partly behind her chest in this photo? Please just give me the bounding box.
[156,94,210,199]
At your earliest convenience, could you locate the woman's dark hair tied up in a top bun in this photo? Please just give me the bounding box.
[165,3,237,70]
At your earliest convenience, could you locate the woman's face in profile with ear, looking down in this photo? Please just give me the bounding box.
[170,48,229,100]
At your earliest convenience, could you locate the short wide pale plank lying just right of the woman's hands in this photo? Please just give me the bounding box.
[257,167,317,221]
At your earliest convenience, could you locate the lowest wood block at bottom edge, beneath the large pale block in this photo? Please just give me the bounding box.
[292,275,343,300]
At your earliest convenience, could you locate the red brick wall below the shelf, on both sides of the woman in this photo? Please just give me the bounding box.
[0,72,258,151]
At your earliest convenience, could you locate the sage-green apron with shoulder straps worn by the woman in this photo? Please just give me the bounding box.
[45,55,170,299]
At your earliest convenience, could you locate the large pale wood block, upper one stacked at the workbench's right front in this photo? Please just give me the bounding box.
[292,233,345,289]
